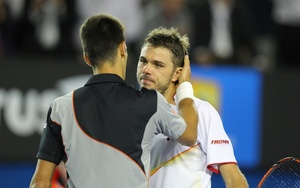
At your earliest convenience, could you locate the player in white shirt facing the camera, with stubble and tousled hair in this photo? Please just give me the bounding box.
[137,27,248,188]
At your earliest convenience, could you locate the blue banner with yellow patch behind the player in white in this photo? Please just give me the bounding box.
[192,65,262,168]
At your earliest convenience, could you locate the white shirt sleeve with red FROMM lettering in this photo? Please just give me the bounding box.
[198,103,236,173]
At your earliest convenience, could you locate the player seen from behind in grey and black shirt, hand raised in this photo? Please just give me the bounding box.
[30,14,198,188]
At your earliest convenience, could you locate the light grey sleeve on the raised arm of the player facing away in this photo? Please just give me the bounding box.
[156,92,186,139]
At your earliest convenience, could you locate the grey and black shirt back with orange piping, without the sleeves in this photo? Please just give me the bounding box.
[51,75,185,187]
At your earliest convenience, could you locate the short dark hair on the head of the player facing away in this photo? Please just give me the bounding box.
[80,14,125,67]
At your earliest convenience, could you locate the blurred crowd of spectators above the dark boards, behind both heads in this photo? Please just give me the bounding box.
[0,0,300,72]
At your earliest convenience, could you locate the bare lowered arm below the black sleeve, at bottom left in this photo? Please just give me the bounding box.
[29,159,56,188]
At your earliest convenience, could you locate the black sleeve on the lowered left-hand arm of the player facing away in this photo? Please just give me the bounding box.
[36,107,65,165]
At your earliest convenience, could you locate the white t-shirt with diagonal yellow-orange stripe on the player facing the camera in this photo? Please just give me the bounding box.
[150,98,237,188]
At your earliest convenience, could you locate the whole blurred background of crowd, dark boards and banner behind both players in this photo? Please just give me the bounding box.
[0,0,300,188]
